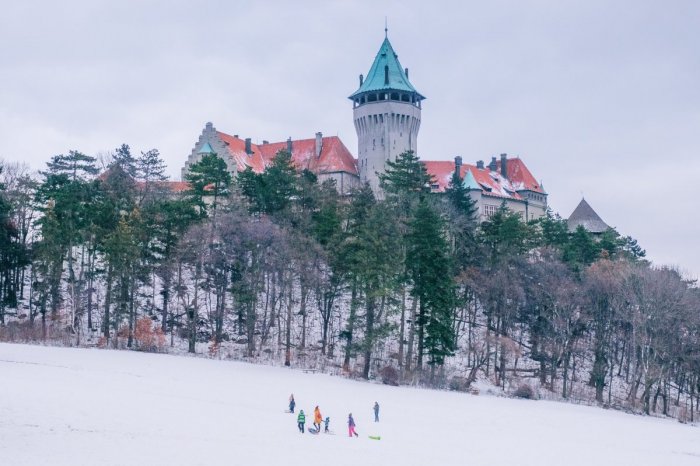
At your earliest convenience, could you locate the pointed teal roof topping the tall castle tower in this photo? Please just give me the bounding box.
[349,37,425,100]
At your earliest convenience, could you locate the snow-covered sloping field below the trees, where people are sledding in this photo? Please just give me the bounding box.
[0,344,700,466]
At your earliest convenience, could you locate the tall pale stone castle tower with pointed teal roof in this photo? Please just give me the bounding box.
[349,32,425,194]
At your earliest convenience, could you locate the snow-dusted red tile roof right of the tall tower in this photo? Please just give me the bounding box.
[423,158,544,199]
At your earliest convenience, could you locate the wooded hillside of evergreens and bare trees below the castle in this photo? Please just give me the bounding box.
[0,145,700,421]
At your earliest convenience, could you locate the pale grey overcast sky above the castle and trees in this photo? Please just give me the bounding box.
[0,0,700,277]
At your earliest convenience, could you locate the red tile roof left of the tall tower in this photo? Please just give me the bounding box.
[217,131,358,175]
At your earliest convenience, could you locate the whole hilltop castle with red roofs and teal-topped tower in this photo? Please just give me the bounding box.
[182,35,547,220]
